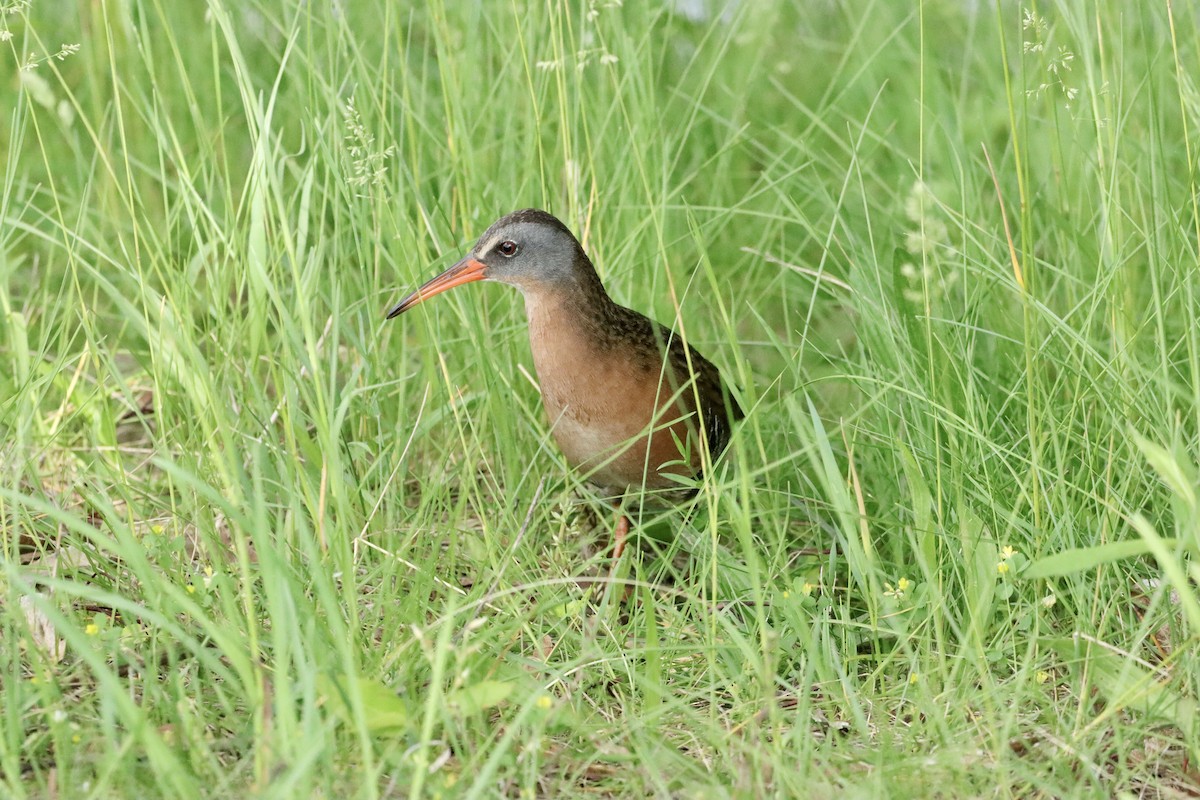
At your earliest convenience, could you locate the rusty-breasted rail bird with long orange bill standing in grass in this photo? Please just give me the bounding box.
[388,209,745,560]
